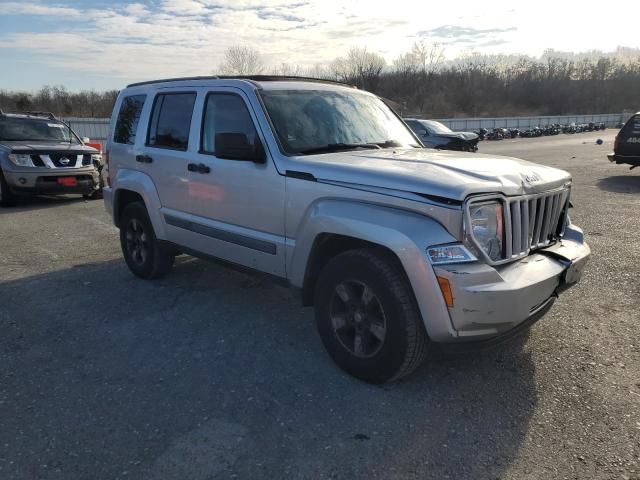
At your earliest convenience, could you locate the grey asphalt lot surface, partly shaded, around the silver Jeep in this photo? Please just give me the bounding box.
[0,130,640,480]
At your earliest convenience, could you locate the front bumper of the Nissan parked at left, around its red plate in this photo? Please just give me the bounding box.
[3,166,100,195]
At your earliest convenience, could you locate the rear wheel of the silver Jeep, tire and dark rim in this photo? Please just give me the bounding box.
[120,202,175,280]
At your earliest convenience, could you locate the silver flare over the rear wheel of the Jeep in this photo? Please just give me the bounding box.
[113,168,167,240]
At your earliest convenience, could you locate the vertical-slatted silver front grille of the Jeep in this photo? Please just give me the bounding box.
[505,188,570,260]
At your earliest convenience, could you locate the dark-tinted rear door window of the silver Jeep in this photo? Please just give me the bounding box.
[147,92,196,150]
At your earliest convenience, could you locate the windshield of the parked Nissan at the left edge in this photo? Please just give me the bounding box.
[0,117,78,143]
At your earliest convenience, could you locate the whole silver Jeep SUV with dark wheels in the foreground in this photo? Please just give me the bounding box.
[104,77,590,383]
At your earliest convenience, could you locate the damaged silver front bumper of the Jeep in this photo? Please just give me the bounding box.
[435,225,591,341]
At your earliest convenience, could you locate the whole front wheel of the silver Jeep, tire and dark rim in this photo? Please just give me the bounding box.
[314,248,430,384]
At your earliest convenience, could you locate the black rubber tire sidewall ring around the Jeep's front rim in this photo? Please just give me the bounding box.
[315,251,416,383]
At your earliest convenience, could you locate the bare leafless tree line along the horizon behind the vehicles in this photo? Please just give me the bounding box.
[0,41,640,118]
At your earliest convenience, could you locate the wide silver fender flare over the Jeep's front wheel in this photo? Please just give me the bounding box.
[287,199,457,341]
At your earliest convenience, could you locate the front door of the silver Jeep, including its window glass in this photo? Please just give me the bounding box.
[184,88,285,276]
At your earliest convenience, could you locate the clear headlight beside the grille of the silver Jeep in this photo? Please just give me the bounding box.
[469,201,504,262]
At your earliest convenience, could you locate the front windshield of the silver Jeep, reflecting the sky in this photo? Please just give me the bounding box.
[261,90,419,155]
